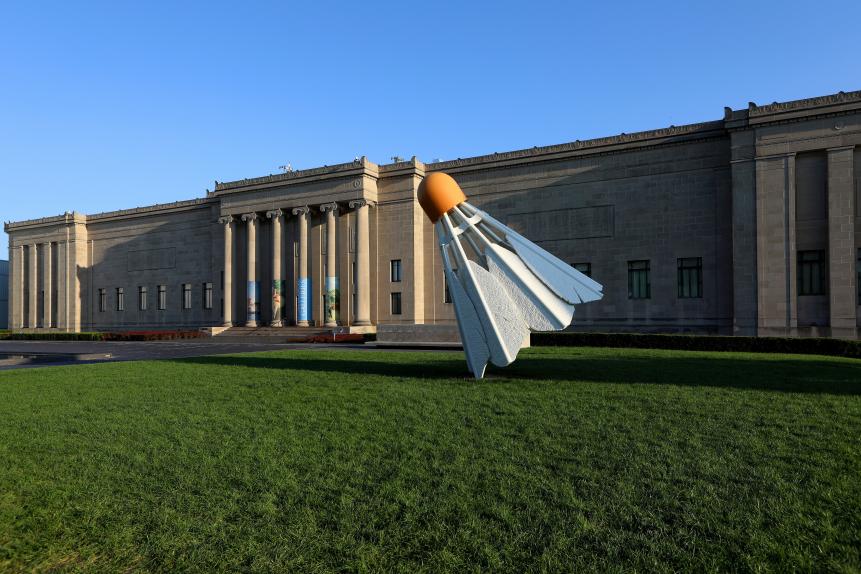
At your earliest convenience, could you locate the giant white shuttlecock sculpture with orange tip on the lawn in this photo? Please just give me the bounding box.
[418,172,602,379]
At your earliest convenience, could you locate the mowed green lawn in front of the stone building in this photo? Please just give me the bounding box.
[0,348,861,572]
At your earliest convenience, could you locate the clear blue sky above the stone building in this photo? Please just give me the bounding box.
[0,0,861,257]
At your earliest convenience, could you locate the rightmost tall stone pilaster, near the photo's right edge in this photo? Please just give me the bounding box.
[828,146,857,339]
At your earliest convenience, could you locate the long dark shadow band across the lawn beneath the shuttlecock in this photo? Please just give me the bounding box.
[174,353,861,395]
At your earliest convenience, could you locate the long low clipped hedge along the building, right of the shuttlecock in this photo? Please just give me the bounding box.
[531,333,861,359]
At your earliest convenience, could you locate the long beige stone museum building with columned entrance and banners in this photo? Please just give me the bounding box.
[6,91,861,338]
